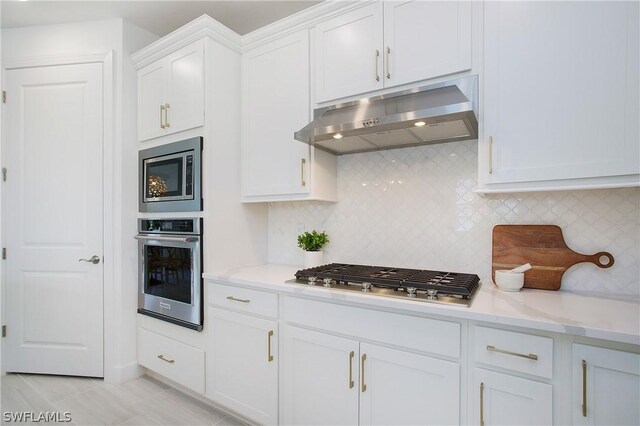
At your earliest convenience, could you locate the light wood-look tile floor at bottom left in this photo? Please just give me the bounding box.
[0,374,243,426]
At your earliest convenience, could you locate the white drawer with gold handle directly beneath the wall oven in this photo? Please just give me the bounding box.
[138,328,205,394]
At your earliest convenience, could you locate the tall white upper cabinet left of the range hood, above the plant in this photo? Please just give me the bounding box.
[242,29,336,202]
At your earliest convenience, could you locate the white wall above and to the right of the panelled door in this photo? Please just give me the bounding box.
[2,19,157,381]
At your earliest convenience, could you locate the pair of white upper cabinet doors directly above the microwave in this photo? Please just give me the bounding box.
[138,40,204,141]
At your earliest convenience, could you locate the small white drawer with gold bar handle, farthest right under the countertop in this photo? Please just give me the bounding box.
[474,326,553,379]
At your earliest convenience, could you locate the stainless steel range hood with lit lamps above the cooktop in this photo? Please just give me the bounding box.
[294,76,478,155]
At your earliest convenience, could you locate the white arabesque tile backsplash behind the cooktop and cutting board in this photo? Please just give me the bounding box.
[269,141,640,297]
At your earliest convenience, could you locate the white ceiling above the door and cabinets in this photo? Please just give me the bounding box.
[0,0,320,36]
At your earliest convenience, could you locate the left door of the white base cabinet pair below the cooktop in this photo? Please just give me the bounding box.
[282,327,360,425]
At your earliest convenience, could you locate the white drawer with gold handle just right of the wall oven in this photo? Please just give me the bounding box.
[209,283,278,318]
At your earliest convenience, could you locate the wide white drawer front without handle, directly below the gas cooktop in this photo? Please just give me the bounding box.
[282,297,460,358]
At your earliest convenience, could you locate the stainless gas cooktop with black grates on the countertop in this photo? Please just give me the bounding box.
[287,263,480,307]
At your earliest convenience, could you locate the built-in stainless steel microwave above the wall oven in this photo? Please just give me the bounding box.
[138,137,202,212]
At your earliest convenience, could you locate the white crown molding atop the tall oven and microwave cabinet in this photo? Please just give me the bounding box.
[131,15,242,69]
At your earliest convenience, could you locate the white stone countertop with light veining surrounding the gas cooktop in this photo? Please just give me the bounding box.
[203,264,640,345]
